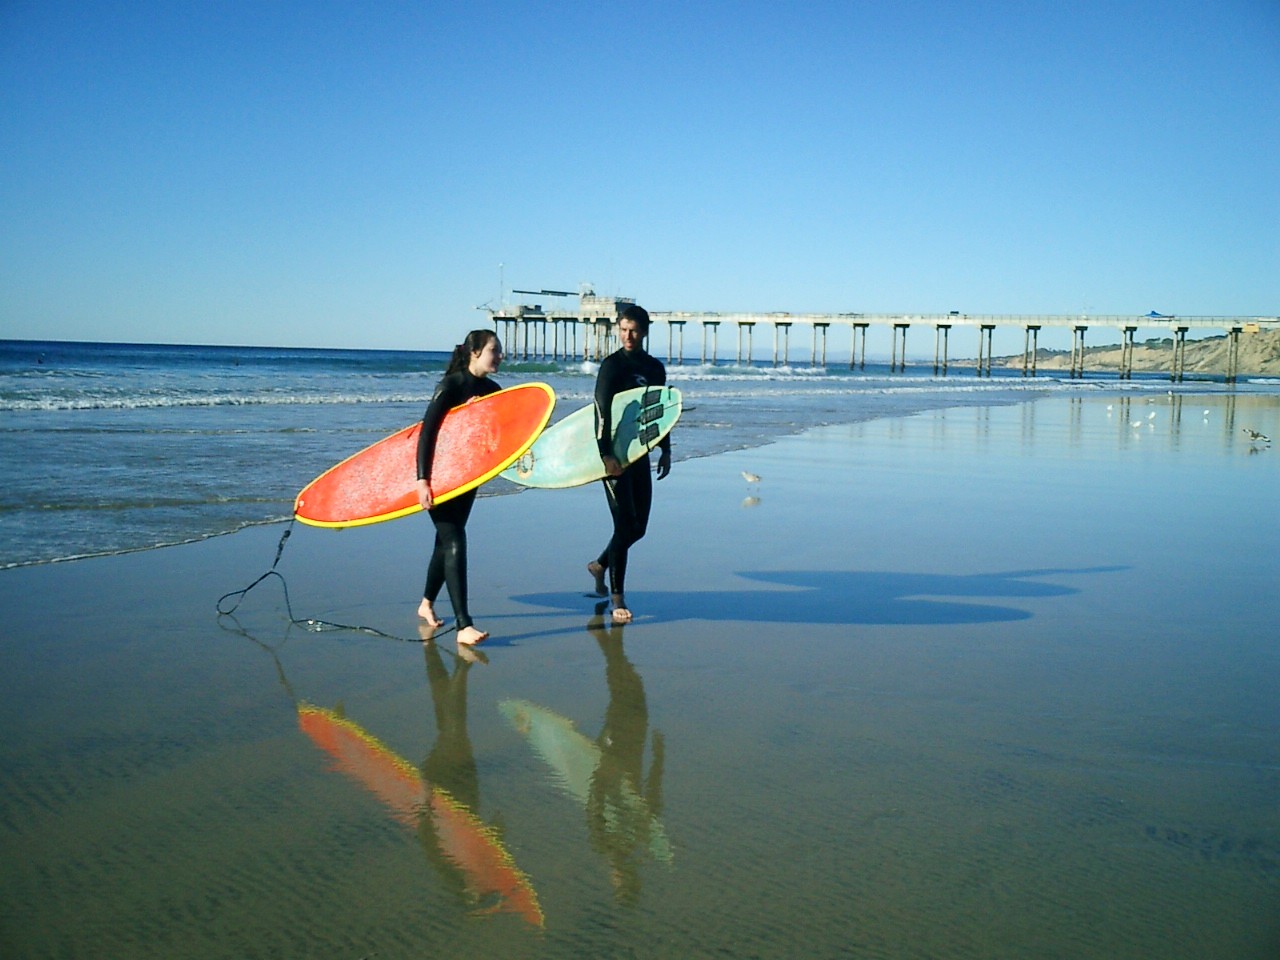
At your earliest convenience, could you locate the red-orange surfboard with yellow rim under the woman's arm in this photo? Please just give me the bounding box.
[293,383,556,527]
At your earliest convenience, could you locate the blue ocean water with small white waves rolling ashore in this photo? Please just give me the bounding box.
[0,340,1280,568]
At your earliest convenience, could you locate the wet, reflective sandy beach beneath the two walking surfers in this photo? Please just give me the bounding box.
[0,396,1280,960]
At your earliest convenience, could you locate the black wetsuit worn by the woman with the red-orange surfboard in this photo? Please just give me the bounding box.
[417,370,502,630]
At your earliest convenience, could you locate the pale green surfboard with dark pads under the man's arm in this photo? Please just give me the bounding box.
[502,387,681,488]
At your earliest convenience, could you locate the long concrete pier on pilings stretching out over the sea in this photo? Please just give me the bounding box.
[489,291,1280,383]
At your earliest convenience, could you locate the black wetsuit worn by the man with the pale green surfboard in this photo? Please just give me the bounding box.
[595,349,671,596]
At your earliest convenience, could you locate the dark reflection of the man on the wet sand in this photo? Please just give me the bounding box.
[586,603,669,905]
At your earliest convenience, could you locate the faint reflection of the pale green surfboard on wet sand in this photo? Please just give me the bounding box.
[498,700,672,863]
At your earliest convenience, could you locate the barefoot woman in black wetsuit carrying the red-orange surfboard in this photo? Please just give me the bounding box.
[417,330,502,644]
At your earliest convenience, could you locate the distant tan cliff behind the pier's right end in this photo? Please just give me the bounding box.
[991,330,1280,376]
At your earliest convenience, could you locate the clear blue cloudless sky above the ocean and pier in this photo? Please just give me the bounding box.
[0,0,1280,349]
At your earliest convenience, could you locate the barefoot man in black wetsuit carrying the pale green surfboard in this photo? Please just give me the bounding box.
[586,303,671,623]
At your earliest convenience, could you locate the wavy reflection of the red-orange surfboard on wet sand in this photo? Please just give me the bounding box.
[298,704,544,927]
